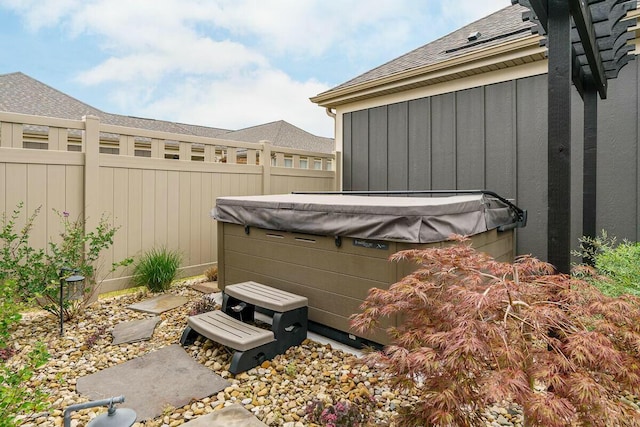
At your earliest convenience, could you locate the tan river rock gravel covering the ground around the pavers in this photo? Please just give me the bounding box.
[8,278,522,427]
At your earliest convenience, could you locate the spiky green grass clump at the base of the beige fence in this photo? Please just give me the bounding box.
[133,248,182,292]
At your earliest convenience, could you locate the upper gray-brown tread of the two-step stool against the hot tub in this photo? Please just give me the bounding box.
[224,281,309,313]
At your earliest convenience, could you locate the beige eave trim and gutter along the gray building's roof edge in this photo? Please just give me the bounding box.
[310,34,546,108]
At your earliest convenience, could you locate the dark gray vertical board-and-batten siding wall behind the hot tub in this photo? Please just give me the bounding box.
[342,61,640,259]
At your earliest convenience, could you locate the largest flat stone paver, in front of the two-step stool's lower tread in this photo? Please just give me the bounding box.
[76,344,230,425]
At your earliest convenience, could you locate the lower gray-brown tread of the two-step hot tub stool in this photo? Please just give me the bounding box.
[187,310,275,351]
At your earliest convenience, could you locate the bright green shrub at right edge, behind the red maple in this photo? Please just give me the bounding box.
[574,230,640,297]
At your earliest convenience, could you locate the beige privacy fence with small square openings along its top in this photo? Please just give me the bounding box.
[0,112,340,293]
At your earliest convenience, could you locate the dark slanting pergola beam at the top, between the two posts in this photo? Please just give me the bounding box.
[569,0,607,99]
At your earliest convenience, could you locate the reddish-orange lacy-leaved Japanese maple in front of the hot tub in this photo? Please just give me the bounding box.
[352,237,640,427]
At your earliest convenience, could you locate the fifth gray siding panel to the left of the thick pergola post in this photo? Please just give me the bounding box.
[407,98,431,190]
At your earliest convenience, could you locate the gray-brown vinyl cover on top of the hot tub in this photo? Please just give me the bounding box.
[211,194,516,243]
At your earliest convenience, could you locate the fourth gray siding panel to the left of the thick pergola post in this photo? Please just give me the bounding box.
[431,93,456,190]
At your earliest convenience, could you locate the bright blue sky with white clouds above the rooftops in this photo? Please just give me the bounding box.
[0,0,511,137]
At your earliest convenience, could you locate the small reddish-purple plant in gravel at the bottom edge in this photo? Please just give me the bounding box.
[305,399,372,427]
